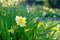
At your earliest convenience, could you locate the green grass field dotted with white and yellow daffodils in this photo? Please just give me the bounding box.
[0,1,60,40]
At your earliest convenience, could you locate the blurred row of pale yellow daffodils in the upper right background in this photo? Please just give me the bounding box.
[26,6,56,17]
